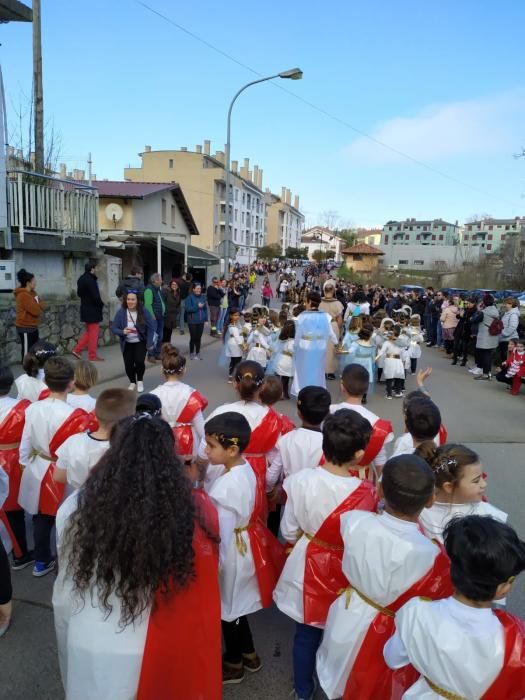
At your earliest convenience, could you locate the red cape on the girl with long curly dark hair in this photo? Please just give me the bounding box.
[137,491,222,700]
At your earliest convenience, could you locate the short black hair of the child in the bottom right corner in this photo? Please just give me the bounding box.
[444,515,525,603]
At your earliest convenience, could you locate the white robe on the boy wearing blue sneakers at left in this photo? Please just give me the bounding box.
[18,398,76,515]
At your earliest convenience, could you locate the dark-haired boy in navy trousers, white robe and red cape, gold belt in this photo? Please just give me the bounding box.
[274,409,377,698]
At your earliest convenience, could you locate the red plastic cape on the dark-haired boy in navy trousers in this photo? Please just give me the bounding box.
[303,481,377,625]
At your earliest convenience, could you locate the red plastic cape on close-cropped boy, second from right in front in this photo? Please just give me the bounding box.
[343,543,453,700]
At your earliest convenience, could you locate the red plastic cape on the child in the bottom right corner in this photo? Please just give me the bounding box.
[481,610,525,700]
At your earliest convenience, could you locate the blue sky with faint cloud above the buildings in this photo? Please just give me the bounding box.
[0,0,525,226]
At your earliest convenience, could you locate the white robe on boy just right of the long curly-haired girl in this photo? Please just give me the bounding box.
[209,462,263,622]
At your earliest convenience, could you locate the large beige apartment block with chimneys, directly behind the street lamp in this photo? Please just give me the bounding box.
[124,141,266,264]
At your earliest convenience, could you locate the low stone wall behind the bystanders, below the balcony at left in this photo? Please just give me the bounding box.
[0,295,118,364]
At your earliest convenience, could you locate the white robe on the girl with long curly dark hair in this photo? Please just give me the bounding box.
[53,493,149,700]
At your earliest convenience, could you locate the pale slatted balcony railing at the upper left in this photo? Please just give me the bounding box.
[7,170,99,243]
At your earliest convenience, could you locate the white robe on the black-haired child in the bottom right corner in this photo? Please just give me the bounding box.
[384,598,505,700]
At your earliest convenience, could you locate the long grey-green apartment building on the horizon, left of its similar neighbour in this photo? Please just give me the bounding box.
[381,219,459,248]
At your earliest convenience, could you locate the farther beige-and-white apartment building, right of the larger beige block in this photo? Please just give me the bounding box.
[265,187,304,255]
